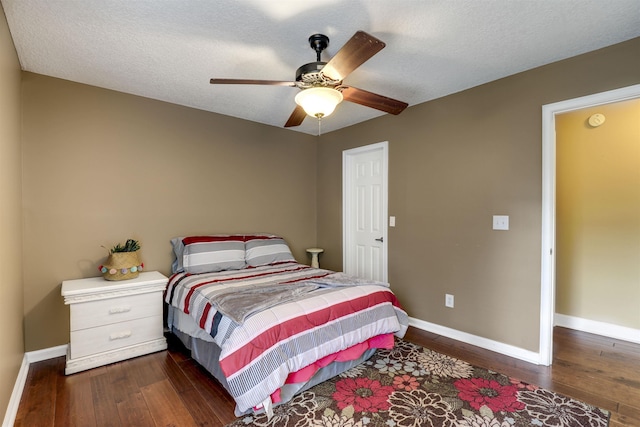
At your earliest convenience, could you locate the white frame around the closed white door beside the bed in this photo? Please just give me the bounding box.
[342,141,389,282]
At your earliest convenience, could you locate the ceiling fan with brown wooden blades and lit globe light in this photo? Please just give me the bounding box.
[210,31,408,127]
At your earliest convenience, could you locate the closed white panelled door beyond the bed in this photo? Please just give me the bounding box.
[342,142,388,282]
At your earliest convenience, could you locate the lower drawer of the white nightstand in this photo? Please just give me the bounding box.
[70,314,163,359]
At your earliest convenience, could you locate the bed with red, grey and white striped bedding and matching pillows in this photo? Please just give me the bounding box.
[165,234,408,416]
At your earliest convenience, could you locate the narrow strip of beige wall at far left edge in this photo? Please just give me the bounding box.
[0,0,24,413]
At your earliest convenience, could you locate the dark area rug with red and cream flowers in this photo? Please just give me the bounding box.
[228,340,609,427]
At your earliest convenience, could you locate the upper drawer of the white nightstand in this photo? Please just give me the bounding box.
[71,292,162,332]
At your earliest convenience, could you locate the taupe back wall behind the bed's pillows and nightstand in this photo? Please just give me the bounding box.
[23,73,316,351]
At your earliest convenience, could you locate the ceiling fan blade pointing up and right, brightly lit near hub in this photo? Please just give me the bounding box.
[322,31,386,81]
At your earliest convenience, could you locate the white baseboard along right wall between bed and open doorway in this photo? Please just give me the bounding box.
[409,317,541,365]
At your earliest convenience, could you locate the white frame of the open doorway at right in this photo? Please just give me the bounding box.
[539,84,640,366]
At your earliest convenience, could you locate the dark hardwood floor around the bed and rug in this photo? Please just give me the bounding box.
[15,328,640,427]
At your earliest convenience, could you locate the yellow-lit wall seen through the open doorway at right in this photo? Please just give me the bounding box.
[556,99,640,329]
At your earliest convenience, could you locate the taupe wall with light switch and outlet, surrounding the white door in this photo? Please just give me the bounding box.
[318,39,640,351]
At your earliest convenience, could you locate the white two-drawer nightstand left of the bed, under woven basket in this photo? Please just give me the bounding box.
[62,271,168,375]
